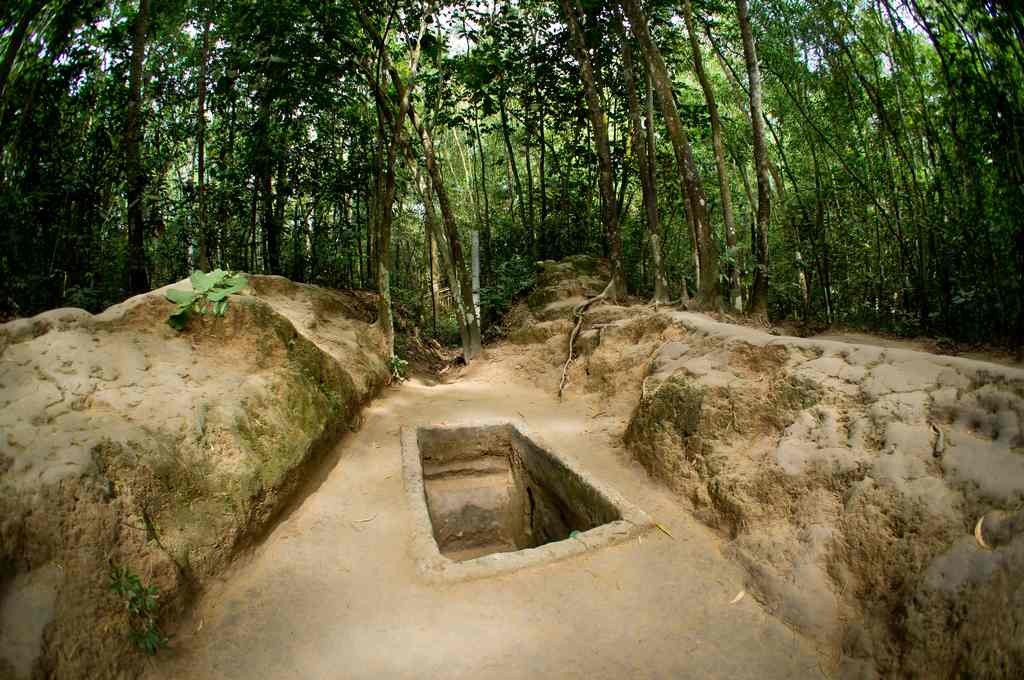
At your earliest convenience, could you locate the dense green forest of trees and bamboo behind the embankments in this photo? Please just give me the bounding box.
[0,0,1024,357]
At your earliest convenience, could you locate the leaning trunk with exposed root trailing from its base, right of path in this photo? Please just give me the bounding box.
[559,0,626,299]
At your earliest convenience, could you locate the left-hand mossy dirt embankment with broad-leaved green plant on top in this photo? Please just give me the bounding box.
[0,277,388,678]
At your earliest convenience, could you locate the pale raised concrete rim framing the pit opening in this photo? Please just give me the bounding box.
[400,420,654,584]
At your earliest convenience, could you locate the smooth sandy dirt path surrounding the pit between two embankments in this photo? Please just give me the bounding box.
[147,356,820,678]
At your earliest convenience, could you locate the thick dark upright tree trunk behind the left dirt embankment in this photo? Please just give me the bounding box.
[125,0,150,295]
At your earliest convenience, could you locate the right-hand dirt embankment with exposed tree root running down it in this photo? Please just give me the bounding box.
[510,258,1024,678]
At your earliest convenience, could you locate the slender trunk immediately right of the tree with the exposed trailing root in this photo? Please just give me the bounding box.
[616,28,670,304]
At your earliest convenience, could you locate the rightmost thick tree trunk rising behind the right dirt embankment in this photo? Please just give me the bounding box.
[736,0,771,317]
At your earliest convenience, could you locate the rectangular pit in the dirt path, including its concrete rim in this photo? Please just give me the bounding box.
[402,423,650,579]
